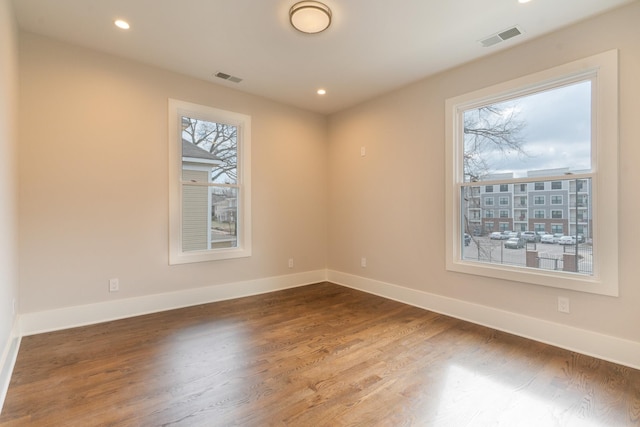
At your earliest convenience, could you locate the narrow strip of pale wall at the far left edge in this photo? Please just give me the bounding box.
[0,0,18,412]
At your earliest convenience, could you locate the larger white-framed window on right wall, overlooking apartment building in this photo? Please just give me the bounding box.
[446,51,618,295]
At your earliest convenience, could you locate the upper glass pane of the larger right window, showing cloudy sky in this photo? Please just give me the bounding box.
[463,80,591,182]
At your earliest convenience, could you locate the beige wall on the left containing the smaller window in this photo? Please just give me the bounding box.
[19,33,327,313]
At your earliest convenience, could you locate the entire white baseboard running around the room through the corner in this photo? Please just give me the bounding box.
[13,270,640,372]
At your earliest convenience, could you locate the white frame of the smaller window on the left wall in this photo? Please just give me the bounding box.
[168,99,251,265]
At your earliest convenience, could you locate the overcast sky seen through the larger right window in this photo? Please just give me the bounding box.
[468,82,591,178]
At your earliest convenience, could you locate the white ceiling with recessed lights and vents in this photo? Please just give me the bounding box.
[13,0,635,114]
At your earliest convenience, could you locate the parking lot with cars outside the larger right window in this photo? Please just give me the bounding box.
[462,236,593,275]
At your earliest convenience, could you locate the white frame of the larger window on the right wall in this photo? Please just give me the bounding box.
[445,50,618,296]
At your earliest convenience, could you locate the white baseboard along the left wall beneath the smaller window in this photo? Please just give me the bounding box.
[20,270,327,336]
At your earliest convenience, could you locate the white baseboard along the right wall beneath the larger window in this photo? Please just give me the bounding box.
[327,270,640,369]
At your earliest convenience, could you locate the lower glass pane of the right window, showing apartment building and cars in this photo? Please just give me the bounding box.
[461,178,593,275]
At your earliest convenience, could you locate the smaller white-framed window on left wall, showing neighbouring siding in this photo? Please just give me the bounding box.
[169,100,251,264]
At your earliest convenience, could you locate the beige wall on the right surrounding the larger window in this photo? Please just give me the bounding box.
[328,2,640,342]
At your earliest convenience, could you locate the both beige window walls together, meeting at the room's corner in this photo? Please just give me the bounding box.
[13,2,640,348]
